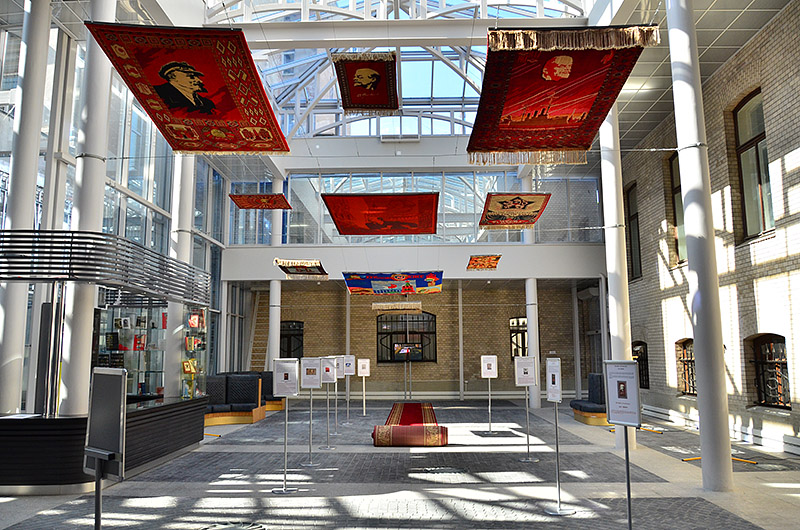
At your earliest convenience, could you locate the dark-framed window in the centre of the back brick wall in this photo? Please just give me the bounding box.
[376,311,436,363]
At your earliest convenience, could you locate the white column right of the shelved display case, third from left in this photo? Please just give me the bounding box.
[164,155,196,397]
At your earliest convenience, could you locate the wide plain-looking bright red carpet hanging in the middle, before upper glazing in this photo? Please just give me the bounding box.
[322,193,439,236]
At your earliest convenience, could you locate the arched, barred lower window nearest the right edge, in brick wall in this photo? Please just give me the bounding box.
[751,334,792,409]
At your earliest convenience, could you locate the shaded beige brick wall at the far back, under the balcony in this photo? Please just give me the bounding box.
[251,280,574,391]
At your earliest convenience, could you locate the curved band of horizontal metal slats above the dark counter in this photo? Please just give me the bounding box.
[0,230,211,306]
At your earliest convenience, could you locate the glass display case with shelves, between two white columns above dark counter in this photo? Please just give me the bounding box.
[93,307,167,397]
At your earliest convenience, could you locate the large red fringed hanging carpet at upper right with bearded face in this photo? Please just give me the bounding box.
[467,26,659,164]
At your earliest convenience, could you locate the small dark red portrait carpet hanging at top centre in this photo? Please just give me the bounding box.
[331,52,399,116]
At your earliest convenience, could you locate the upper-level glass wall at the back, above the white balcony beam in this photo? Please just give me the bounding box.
[229,171,603,245]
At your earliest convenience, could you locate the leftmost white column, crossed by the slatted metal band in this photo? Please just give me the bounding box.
[0,0,50,413]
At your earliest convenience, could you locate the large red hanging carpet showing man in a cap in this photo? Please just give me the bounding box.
[86,22,289,154]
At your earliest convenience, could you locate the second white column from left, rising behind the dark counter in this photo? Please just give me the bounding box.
[59,0,117,416]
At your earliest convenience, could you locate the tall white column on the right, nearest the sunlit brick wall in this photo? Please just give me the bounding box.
[667,0,733,491]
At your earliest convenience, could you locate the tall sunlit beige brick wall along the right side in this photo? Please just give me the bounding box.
[623,1,800,434]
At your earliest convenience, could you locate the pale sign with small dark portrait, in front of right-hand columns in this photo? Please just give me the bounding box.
[603,361,642,427]
